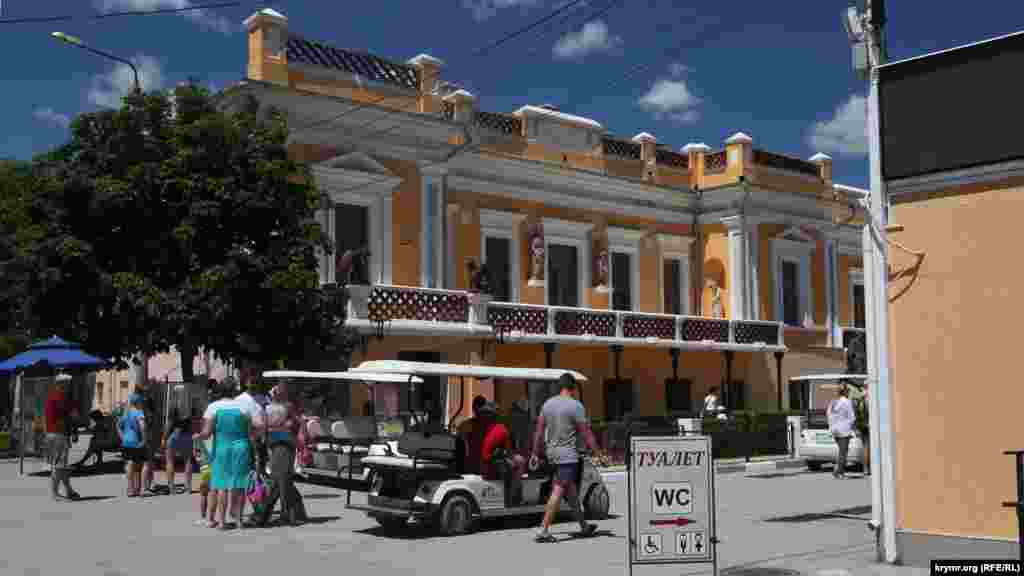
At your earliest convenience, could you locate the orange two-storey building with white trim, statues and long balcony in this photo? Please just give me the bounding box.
[225,9,863,419]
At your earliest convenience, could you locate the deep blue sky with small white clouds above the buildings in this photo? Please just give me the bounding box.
[0,0,1024,187]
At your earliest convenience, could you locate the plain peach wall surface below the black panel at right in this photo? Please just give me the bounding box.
[890,181,1024,538]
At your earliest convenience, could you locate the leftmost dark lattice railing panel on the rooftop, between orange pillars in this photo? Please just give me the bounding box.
[288,34,420,90]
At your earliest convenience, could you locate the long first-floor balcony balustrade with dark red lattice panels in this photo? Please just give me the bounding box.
[348,285,786,346]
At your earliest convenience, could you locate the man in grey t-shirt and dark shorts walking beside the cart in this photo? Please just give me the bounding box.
[529,374,605,542]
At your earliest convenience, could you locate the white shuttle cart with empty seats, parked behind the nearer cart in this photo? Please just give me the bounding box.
[263,370,423,482]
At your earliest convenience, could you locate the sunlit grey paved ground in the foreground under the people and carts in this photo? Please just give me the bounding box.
[0,440,925,576]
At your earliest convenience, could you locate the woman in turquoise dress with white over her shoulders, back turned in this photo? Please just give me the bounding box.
[197,383,252,529]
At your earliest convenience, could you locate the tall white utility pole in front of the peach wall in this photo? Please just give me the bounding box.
[844,0,898,564]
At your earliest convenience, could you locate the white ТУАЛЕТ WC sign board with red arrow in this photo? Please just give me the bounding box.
[628,436,715,567]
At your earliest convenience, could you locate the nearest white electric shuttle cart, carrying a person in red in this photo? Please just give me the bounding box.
[346,361,610,535]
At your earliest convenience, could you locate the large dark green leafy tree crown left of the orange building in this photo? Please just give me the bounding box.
[16,80,352,380]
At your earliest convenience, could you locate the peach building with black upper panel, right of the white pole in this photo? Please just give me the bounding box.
[880,33,1024,566]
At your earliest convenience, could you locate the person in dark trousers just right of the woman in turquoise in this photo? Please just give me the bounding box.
[256,385,306,526]
